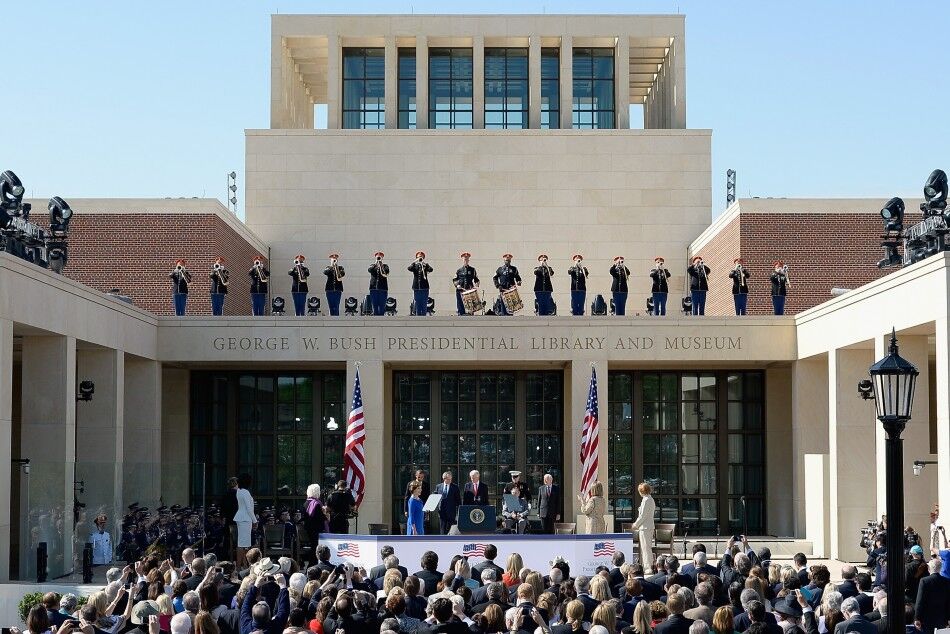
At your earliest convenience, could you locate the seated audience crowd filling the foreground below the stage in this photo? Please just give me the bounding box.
[15,537,950,634]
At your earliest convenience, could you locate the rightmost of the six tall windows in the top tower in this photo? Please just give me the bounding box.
[571,48,616,129]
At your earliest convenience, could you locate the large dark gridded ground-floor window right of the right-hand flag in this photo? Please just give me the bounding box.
[607,371,766,535]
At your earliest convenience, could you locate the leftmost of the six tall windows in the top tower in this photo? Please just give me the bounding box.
[343,48,386,129]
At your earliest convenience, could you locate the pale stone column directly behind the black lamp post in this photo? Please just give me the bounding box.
[880,333,946,538]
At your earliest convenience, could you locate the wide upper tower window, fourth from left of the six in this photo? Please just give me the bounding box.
[485,48,528,130]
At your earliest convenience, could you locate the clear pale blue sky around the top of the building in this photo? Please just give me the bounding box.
[0,0,950,220]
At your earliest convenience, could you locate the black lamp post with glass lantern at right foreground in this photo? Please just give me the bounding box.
[868,329,920,632]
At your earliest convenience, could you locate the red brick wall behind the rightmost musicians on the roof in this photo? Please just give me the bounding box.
[700,212,921,315]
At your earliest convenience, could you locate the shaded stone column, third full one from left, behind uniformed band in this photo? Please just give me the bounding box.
[122,355,162,508]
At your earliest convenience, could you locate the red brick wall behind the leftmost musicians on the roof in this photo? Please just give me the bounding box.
[52,213,267,315]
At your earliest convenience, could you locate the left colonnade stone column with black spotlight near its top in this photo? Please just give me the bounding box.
[76,348,125,548]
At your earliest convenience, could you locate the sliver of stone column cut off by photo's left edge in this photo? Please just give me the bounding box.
[0,319,13,582]
